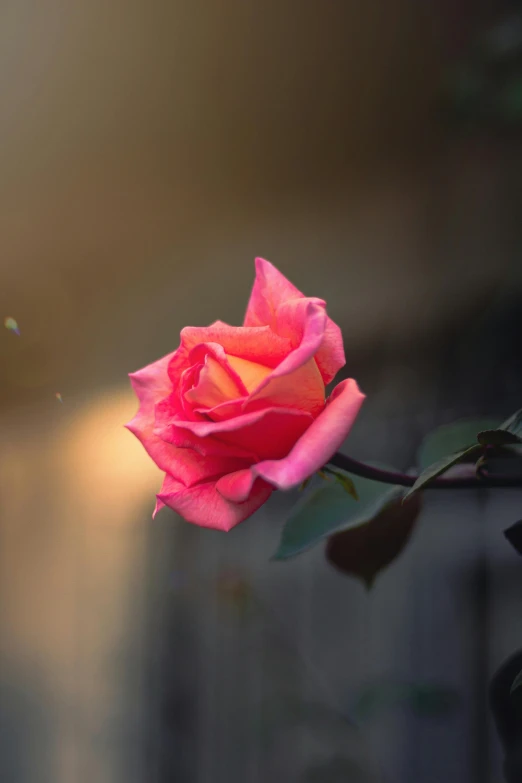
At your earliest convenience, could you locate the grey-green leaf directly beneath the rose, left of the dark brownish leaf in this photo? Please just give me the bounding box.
[273,478,402,560]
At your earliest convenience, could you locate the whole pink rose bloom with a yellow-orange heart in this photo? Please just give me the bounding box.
[126,258,364,530]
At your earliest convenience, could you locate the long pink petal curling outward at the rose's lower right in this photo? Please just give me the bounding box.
[252,378,365,489]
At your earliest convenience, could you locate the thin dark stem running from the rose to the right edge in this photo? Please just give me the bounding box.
[328,451,522,489]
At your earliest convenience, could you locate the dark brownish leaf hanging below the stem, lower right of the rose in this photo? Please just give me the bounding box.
[326,487,422,590]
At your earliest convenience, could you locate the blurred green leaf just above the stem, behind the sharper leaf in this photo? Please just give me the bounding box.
[417,419,501,471]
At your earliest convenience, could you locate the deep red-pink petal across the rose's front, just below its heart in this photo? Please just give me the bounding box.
[172,408,314,460]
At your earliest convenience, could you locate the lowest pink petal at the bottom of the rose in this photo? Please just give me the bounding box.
[155,476,273,531]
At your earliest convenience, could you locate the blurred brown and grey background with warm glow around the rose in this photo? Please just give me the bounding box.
[0,0,522,783]
